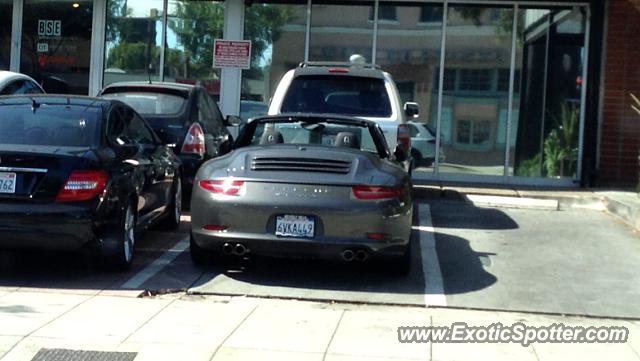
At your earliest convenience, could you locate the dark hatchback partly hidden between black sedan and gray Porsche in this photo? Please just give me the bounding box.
[100,82,239,197]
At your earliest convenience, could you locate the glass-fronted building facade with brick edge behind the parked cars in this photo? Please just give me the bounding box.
[0,0,640,186]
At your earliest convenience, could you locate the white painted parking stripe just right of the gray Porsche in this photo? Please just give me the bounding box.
[418,203,447,307]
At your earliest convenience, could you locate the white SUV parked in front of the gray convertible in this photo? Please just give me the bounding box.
[269,62,420,171]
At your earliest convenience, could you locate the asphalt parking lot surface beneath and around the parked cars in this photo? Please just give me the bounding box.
[0,197,640,318]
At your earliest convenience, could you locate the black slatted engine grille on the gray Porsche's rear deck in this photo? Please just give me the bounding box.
[251,157,351,174]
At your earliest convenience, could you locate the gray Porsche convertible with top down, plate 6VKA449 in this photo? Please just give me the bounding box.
[190,114,413,273]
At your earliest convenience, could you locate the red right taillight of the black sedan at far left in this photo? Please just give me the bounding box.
[56,170,109,202]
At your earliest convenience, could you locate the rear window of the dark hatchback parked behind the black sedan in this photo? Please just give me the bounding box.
[103,92,187,115]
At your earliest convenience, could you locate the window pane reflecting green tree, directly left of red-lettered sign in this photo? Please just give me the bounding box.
[164,0,224,99]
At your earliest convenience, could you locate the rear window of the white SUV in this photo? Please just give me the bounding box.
[281,75,391,117]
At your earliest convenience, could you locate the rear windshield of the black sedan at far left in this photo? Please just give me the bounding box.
[0,104,100,147]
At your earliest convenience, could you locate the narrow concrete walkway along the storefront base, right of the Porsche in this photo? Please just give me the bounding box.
[414,185,640,231]
